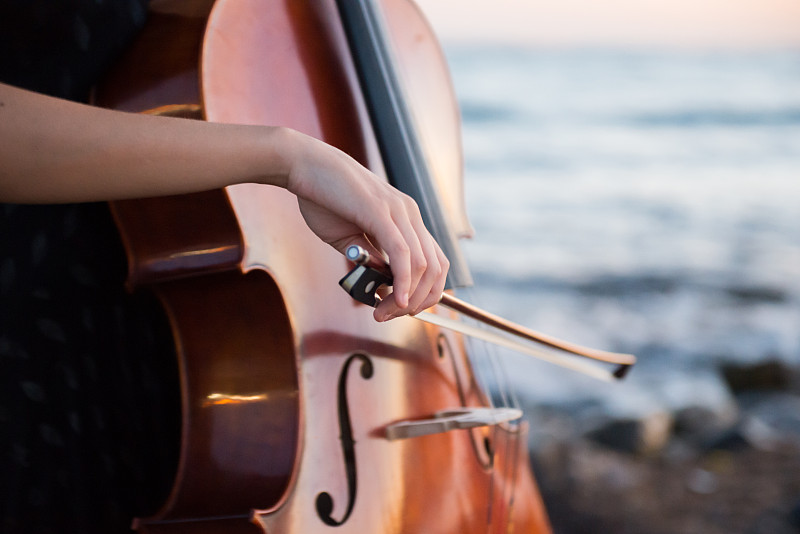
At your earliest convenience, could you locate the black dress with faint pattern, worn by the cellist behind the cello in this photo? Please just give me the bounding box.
[0,0,180,534]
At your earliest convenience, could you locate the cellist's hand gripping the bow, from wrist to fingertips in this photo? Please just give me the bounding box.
[287,131,450,321]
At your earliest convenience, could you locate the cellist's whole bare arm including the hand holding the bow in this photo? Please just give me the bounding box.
[0,84,448,320]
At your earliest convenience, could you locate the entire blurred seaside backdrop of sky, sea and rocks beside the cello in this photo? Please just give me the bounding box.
[418,0,800,534]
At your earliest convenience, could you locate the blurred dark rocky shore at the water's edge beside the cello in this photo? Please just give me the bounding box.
[528,361,800,534]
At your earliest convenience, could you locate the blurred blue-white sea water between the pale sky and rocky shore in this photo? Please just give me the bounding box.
[445,46,800,413]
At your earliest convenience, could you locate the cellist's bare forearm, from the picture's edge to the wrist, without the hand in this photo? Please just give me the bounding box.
[0,84,291,203]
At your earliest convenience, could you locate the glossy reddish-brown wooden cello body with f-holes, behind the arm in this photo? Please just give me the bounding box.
[96,0,549,534]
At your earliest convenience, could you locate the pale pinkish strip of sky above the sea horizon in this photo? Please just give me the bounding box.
[416,0,800,49]
